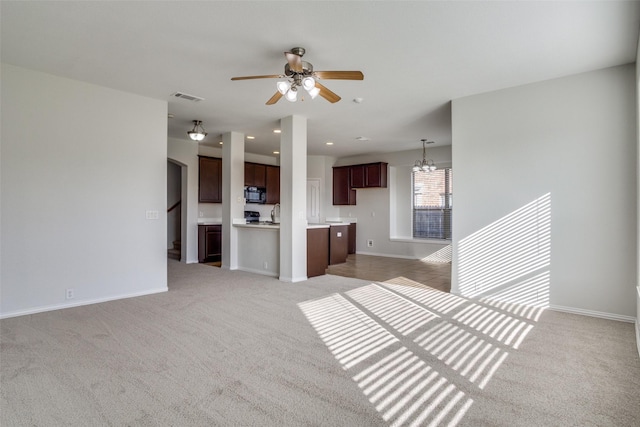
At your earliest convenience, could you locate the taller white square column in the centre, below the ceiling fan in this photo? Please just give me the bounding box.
[280,116,307,282]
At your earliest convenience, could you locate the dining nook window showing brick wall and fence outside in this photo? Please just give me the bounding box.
[412,168,453,240]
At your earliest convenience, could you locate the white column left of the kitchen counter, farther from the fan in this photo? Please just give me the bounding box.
[222,132,244,270]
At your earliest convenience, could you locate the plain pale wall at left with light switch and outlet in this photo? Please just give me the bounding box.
[0,64,167,317]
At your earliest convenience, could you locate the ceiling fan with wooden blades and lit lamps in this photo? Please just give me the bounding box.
[231,47,364,105]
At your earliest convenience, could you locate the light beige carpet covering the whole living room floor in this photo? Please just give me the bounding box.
[0,260,640,426]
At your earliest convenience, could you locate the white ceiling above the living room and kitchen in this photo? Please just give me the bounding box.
[0,0,640,157]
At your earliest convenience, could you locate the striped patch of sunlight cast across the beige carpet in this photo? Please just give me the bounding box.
[298,277,542,426]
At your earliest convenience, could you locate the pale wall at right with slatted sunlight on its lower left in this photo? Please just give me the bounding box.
[452,65,637,319]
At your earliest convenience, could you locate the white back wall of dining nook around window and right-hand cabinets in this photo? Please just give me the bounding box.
[327,145,451,259]
